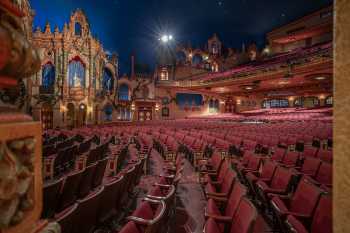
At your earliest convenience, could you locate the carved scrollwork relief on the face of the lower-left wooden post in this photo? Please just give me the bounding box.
[0,137,36,228]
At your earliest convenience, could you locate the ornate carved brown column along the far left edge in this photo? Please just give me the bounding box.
[0,0,59,233]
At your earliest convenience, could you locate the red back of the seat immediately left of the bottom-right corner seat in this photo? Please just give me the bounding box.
[290,179,322,217]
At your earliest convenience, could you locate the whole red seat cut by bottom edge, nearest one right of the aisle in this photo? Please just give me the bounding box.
[204,198,257,233]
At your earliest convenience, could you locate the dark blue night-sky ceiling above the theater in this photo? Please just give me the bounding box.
[30,0,333,72]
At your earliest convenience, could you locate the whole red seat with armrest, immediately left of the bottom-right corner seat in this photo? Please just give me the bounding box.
[271,179,322,229]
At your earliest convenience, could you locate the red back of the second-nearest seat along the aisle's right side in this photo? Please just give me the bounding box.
[225,180,247,217]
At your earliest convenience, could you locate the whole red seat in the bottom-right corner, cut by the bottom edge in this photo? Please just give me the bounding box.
[286,195,332,233]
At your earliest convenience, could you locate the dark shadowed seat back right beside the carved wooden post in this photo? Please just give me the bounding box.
[41,178,63,219]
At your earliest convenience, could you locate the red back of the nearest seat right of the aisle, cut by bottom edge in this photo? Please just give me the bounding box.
[230,197,258,233]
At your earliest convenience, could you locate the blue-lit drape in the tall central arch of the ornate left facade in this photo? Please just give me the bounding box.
[68,59,85,88]
